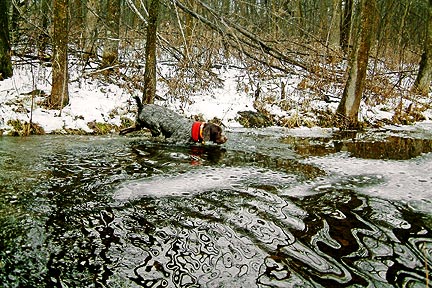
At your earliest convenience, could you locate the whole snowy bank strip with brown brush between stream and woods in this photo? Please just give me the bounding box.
[0,59,432,135]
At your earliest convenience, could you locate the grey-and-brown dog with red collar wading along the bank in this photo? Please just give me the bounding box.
[120,97,228,144]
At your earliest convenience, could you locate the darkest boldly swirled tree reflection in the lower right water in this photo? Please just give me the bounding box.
[288,189,432,287]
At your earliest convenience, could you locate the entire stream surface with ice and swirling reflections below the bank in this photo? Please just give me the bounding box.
[0,129,432,287]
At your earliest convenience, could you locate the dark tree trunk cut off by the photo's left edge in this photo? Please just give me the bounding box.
[0,0,13,81]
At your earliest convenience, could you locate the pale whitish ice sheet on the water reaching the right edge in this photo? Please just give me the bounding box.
[298,152,432,214]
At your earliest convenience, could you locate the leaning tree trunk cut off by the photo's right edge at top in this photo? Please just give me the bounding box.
[412,0,432,95]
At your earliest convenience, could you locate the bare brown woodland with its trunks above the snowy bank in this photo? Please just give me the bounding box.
[0,0,432,127]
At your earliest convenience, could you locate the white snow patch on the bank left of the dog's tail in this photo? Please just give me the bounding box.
[0,65,134,134]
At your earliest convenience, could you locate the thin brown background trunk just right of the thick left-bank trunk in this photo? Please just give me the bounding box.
[84,0,99,63]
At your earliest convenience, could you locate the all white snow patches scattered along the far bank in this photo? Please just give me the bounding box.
[0,57,432,135]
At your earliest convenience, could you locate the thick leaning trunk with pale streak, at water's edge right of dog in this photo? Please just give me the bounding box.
[336,0,376,129]
